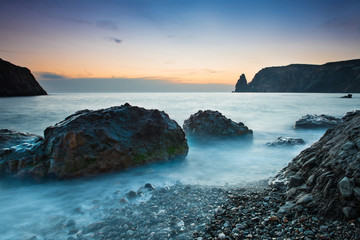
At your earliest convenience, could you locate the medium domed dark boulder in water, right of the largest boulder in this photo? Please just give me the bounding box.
[183,110,252,137]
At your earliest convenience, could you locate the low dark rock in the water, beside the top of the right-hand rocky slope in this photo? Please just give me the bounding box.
[294,114,341,129]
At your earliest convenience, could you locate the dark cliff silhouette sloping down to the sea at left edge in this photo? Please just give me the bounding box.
[0,58,47,97]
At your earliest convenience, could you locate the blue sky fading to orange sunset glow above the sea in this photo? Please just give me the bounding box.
[0,0,360,90]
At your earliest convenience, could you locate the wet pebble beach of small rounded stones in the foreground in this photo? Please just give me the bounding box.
[51,181,360,240]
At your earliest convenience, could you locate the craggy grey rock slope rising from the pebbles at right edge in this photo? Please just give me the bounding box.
[273,111,360,219]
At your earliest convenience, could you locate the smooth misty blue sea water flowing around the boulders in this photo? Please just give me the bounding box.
[0,93,360,239]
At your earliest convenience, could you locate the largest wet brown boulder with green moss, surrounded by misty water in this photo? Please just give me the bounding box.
[0,104,188,179]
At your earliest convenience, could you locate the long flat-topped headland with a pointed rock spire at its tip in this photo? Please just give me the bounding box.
[235,59,360,93]
